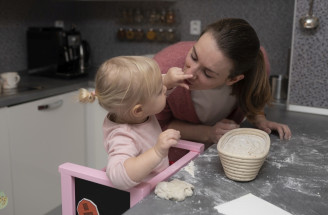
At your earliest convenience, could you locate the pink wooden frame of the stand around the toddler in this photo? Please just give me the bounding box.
[59,140,204,215]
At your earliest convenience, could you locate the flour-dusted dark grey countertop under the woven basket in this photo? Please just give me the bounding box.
[125,105,328,215]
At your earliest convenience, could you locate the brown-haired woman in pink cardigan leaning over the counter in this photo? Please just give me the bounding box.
[154,18,291,146]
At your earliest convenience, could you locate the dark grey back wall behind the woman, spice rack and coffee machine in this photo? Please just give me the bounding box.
[0,0,294,74]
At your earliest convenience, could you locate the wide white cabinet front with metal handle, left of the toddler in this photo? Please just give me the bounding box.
[8,92,86,215]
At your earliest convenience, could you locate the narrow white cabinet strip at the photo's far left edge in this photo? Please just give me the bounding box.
[0,107,14,215]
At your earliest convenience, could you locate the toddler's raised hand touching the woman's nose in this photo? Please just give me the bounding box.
[163,67,192,90]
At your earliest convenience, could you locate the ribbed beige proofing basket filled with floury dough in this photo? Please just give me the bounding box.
[217,128,270,181]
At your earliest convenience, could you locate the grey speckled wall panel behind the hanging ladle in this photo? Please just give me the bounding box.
[289,0,328,111]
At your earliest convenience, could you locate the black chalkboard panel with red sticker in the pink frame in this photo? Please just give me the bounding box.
[75,178,130,215]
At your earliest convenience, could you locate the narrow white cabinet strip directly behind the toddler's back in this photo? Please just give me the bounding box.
[85,89,107,169]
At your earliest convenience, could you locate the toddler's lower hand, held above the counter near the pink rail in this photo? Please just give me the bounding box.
[154,129,181,158]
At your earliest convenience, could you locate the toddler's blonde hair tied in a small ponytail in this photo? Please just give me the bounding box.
[79,56,162,114]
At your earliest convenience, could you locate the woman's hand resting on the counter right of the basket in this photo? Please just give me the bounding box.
[252,115,292,140]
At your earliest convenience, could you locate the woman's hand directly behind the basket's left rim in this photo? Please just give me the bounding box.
[208,119,240,144]
